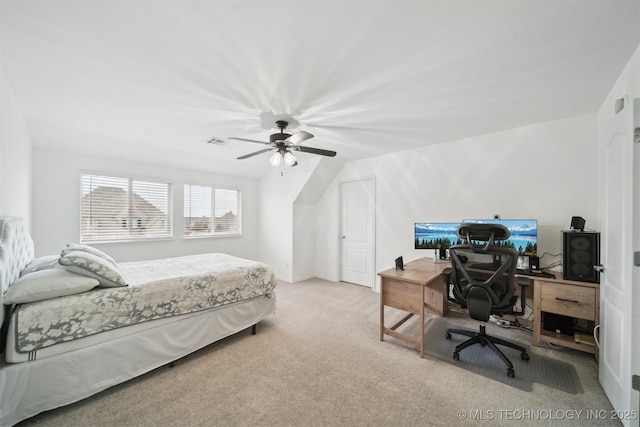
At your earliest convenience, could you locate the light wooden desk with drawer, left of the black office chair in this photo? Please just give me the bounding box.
[378,258,451,357]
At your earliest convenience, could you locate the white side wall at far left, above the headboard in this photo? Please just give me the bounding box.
[0,68,32,229]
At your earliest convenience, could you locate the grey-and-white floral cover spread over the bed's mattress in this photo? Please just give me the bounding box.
[14,253,277,353]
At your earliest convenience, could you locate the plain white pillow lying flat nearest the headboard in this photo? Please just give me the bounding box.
[3,268,100,304]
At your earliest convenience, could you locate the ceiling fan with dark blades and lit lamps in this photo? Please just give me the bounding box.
[228,120,336,167]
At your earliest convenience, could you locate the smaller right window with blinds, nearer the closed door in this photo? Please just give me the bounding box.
[184,184,241,236]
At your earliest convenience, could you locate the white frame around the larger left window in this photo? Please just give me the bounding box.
[80,170,175,244]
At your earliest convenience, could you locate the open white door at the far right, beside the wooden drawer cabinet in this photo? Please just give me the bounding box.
[598,97,640,425]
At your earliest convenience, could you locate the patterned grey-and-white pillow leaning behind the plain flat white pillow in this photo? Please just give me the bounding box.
[59,251,127,288]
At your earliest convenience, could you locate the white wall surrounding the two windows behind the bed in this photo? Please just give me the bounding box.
[32,147,261,262]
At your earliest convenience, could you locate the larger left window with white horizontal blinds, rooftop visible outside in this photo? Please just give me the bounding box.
[81,175,172,242]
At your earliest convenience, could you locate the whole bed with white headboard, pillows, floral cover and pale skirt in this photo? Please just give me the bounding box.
[0,217,277,426]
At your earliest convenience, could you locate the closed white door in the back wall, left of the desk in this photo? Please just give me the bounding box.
[340,179,375,288]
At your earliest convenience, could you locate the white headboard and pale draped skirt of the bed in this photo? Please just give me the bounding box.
[0,217,276,426]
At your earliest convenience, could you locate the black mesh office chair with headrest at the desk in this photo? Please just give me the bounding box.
[445,223,529,377]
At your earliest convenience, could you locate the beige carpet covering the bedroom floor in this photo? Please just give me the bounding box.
[20,280,620,427]
